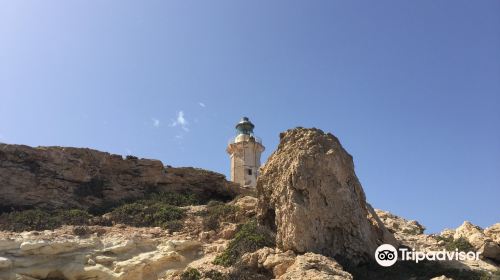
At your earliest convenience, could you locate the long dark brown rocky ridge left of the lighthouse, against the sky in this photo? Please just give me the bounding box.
[0,144,238,210]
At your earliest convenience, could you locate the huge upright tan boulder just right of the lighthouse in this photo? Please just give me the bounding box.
[257,128,397,263]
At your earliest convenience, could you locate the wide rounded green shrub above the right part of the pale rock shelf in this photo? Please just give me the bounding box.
[110,202,186,228]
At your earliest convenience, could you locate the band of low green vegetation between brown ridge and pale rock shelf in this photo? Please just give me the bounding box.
[0,190,208,234]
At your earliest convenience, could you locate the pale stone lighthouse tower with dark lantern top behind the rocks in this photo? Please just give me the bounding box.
[226,117,265,187]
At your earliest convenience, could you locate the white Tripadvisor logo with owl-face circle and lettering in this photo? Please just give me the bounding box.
[375,244,481,267]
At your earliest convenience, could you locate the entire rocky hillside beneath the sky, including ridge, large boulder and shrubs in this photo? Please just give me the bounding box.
[0,128,500,280]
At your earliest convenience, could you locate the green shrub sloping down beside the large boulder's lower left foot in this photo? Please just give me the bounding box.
[214,221,275,266]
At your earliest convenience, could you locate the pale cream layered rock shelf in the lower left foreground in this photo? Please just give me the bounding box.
[0,228,201,280]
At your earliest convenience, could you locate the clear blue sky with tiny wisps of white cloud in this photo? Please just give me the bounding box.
[0,0,500,232]
